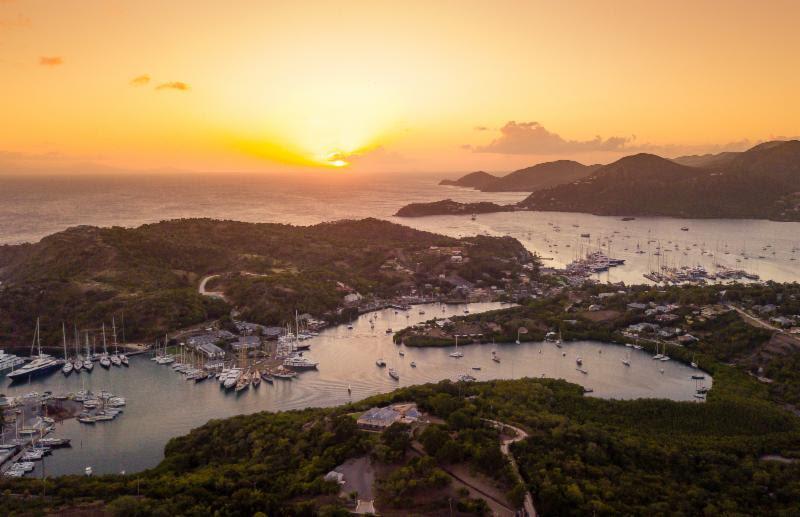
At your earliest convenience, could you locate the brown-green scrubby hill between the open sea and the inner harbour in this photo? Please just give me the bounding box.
[0,219,527,349]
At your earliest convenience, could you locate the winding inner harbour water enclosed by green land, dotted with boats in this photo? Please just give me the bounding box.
[0,303,711,475]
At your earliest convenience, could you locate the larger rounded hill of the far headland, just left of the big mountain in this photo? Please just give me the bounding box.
[480,160,600,192]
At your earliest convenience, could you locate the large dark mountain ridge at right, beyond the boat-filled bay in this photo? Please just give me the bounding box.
[519,140,800,221]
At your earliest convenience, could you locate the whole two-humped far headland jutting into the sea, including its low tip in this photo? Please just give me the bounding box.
[439,160,600,192]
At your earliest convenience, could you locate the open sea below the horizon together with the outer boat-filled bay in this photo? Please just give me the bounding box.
[0,174,800,283]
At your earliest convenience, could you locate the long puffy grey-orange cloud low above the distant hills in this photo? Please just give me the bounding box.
[471,121,633,154]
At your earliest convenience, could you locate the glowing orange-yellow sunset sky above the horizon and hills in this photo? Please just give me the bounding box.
[0,0,800,174]
